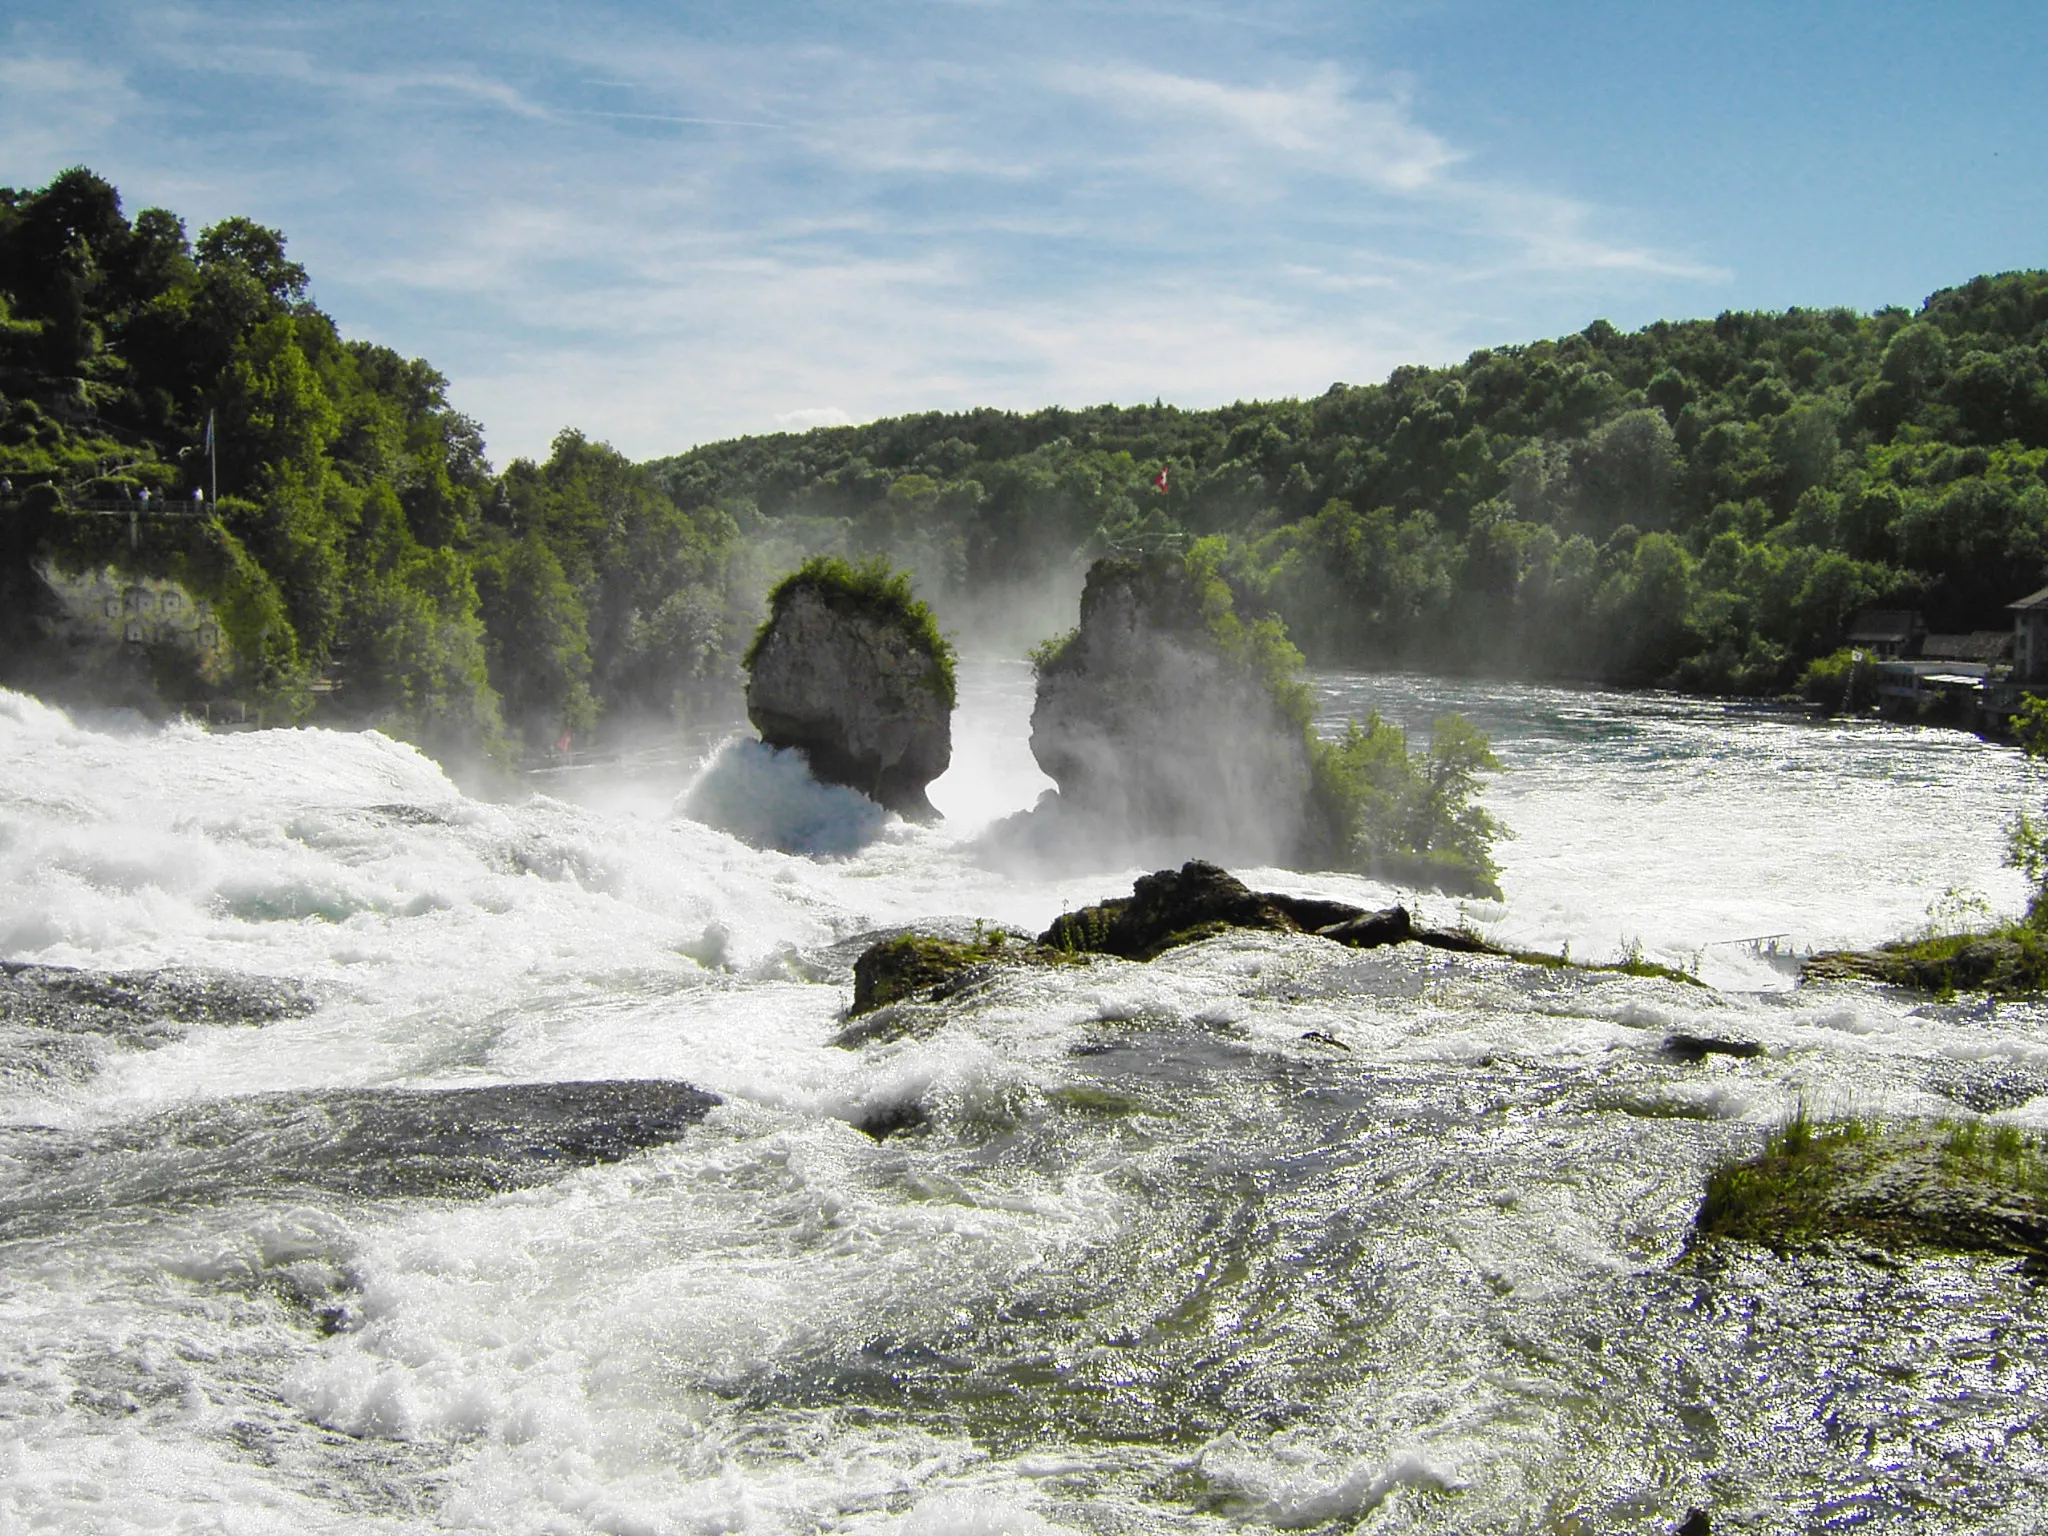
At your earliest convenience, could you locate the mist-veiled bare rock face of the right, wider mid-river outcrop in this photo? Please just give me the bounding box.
[1030,559,1309,864]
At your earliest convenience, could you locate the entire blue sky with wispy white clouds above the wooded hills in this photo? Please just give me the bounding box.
[0,0,2048,463]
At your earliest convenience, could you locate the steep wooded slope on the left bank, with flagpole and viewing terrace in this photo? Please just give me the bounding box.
[0,170,733,752]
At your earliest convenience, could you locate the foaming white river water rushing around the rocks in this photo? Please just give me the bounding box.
[0,664,2048,1536]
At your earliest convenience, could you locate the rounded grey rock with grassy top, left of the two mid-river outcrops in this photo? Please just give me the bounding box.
[748,561,952,821]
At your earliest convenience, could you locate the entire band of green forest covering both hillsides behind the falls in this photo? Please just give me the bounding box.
[0,170,2048,752]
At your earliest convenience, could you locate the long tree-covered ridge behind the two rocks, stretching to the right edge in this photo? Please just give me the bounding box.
[655,272,2048,692]
